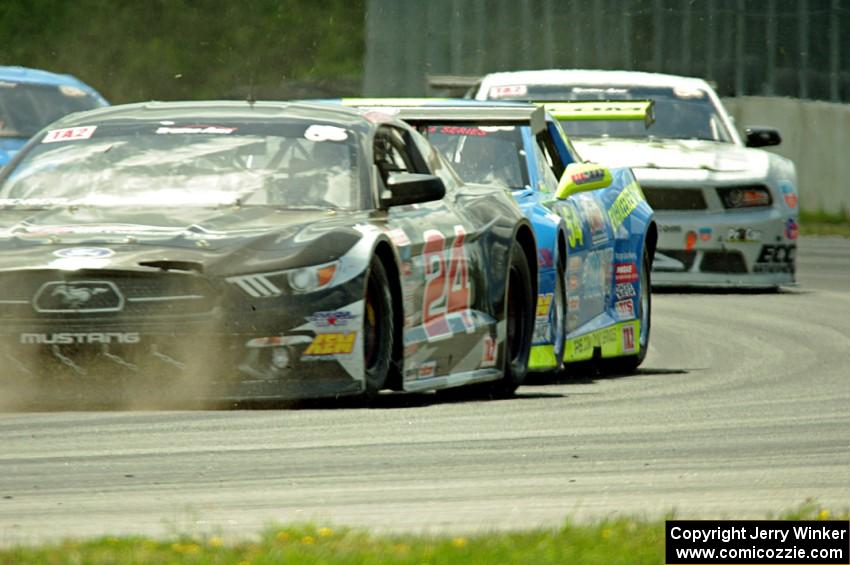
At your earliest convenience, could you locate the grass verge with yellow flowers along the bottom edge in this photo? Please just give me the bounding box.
[0,502,847,565]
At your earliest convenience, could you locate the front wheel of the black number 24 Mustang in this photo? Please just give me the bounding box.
[362,257,395,401]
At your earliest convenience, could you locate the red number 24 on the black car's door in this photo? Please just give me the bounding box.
[422,225,471,324]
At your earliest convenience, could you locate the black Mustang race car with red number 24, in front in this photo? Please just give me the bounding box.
[0,102,537,400]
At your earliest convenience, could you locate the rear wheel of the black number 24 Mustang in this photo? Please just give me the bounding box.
[490,242,537,398]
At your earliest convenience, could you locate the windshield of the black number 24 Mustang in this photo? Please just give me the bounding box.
[0,120,359,209]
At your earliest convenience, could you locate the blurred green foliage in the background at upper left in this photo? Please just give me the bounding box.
[0,0,365,103]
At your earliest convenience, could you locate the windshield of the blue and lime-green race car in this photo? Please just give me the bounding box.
[423,124,529,189]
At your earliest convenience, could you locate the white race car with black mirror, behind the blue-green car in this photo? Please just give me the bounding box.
[474,70,799,287]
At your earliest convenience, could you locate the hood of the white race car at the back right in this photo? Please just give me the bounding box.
[573,138,769,174]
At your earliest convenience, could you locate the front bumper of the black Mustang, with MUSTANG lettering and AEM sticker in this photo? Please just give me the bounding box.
[0,275,372,401]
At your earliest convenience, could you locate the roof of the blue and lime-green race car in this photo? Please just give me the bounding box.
[342,98,546,133]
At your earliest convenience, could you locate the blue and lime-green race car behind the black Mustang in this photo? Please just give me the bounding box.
[343,99,658,373]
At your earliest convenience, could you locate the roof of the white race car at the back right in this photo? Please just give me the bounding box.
[481,69,710,90]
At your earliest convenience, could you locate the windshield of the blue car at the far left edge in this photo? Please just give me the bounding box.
[0,80,102,138]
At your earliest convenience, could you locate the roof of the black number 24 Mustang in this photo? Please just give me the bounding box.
[41,100,392,133]
